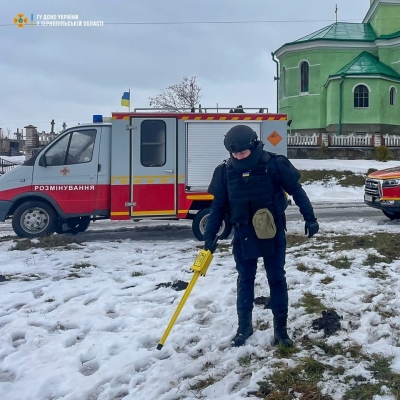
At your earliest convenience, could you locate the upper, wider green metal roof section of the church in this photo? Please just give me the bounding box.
[291,22,376,44]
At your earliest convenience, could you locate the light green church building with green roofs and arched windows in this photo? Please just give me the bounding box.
[273,0,400,134]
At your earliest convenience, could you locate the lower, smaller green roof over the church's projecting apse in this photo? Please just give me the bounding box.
[330,51,400,80]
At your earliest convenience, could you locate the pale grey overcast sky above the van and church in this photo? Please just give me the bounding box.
[0,0,370,132]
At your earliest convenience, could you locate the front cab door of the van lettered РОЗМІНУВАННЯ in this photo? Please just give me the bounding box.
[32,127,101,215]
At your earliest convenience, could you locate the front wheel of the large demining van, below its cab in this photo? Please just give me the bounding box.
[12,201,57,238]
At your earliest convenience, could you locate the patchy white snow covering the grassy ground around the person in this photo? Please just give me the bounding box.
[0,160,400,400]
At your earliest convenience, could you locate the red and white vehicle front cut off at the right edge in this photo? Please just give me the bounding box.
[364,166,400,220]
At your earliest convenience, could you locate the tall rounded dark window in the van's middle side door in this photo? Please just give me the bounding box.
[140,120,167,167]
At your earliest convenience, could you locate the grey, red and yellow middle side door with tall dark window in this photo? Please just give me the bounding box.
[131,117,177,217]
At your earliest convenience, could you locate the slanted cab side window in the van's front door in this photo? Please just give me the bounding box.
[45,129,96,166]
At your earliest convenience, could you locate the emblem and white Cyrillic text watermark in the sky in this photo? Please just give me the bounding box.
[14,14,104,28]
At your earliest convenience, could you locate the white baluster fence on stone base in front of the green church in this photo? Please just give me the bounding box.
[288,132,400,159]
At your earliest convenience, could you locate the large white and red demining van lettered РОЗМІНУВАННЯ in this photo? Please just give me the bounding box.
[0,108,287,240]
